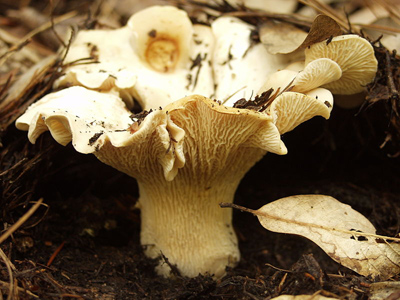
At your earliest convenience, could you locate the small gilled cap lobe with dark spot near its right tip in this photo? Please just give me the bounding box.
[268,88,333,134]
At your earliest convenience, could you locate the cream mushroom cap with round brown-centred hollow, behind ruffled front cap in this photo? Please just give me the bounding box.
[55,6,215,110]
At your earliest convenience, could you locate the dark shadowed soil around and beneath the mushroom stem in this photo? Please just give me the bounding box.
[0,0,400,300]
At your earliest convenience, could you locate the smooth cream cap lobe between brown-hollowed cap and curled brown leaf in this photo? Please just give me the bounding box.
[212,17,286,106]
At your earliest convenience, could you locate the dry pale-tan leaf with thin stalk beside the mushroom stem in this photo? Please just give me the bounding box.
[221,195,400,280]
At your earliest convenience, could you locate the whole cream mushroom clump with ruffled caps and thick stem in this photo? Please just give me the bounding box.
[16,6,378,277]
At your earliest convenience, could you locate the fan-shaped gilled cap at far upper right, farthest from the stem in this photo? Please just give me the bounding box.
[305,34,378,94]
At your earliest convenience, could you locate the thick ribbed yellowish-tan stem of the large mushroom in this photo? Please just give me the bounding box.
[139,168,247,278]
